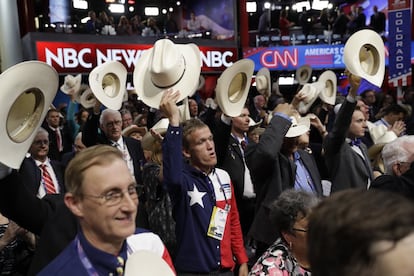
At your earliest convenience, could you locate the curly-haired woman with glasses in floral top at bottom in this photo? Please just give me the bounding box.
[249,189,319,276]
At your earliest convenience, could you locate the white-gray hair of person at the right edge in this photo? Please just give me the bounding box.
[381,135,414,174]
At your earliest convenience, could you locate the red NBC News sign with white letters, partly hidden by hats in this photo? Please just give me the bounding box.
[36,41,238,73]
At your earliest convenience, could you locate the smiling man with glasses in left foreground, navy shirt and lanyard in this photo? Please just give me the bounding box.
[39,146,173,275]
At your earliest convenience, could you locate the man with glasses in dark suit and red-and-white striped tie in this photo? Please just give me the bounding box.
[19,128,65,198]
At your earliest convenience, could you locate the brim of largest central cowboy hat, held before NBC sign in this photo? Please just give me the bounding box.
[133,43,201,109]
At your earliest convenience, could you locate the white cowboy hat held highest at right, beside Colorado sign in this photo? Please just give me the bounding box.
[344,29,385,87]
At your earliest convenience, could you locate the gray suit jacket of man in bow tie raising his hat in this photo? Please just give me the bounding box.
[323,100,373,193]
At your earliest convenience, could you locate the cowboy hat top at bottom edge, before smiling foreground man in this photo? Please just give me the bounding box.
[124,250,175,276]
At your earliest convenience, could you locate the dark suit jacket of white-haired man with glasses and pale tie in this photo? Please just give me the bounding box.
[82,113,145,185]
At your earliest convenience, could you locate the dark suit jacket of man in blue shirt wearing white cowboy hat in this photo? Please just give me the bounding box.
[246,115,322,245]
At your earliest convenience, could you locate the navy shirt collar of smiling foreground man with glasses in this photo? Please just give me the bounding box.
[78,230,128,275]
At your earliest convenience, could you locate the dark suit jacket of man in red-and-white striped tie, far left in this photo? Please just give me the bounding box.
[19,157,66,195]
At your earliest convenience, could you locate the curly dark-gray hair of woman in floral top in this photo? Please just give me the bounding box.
[270,189,319,236]
